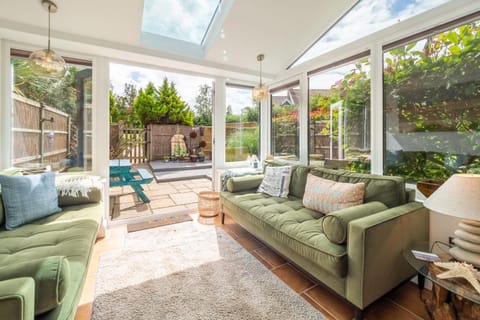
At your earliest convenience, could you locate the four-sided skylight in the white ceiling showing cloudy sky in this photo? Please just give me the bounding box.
[142,0,222,45]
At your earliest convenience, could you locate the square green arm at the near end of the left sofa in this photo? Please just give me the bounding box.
[0,277,35,320]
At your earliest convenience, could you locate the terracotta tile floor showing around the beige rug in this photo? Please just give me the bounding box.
[75,212,429,320]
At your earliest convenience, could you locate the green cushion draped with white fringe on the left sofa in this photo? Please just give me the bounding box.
[55,174,103,207]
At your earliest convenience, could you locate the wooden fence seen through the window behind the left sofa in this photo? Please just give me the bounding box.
[12,95,71,169]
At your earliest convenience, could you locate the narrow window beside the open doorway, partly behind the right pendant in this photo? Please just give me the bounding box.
[225,85,260,162]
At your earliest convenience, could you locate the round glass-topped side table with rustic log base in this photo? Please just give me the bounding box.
[403,242,480,320]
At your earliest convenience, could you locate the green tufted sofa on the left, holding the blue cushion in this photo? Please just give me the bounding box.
[0,175,104,320]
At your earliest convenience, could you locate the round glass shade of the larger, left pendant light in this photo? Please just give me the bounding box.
[28,49,67,78]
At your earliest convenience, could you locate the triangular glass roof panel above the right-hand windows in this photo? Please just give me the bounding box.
[291,0,449,67]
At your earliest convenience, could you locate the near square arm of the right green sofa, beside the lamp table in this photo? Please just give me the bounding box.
[346,202,429,309]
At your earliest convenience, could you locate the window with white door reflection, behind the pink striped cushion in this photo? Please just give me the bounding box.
[309,58,370,172]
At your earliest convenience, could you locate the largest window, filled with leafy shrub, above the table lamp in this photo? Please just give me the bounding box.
[384,20,480,181]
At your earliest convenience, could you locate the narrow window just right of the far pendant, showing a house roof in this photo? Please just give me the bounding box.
[271,83,300,160]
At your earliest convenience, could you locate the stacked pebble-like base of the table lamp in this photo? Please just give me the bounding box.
[449,219,480,267]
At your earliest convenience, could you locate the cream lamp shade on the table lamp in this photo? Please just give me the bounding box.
[423,174,480,220]
